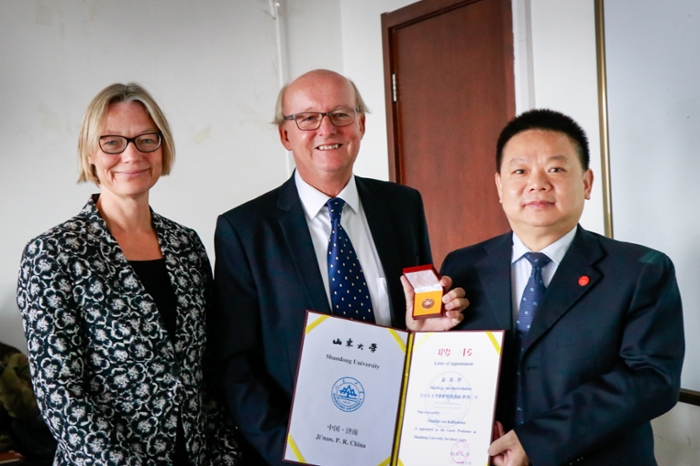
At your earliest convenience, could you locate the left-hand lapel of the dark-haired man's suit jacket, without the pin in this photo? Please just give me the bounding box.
[476,233,513,329]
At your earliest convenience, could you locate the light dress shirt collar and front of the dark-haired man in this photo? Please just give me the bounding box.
[510,227,577,321]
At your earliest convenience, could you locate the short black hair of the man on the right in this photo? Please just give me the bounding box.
[496,108,591,173]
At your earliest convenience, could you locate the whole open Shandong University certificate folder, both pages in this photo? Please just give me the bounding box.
[284,312,503,466]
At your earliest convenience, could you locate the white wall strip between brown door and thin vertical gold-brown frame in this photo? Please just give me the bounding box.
[512,0,605,234]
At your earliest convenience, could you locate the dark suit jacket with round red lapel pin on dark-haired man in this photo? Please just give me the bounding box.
[442,226,684,466]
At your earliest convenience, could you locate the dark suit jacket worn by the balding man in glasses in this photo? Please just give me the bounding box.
[213,177,432,464]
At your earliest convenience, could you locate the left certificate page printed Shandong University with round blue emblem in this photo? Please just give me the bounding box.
[284,312,408,466]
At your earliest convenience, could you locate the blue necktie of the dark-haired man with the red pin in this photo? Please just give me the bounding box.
[515,252,551,424]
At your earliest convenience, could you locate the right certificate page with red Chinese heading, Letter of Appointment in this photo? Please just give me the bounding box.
[399,331,503,466]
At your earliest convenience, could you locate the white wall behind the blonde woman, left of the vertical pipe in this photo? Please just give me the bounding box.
[0,0,288,348]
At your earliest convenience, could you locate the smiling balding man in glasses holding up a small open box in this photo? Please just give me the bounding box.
[212,70,466,464]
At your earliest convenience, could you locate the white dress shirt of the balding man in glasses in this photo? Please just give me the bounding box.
[294,171,394,327]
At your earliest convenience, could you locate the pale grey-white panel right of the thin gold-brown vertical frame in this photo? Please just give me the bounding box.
[605,0,700,391]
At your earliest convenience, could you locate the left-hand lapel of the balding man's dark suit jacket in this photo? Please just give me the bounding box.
[277,175,331,314]
